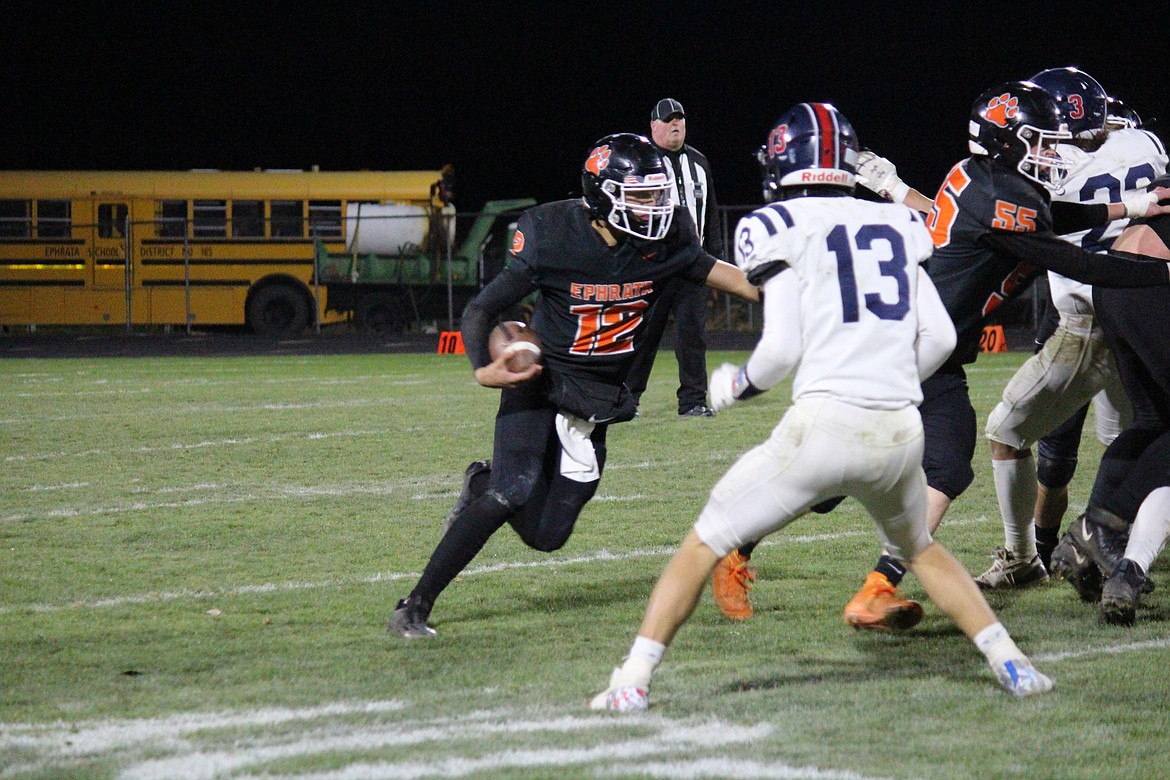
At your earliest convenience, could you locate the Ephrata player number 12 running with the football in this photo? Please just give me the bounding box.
[388,133,759,637]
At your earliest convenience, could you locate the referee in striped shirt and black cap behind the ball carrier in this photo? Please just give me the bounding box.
[626,97,724,417]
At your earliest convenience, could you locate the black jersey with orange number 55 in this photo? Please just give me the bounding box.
[927,157,1052,365]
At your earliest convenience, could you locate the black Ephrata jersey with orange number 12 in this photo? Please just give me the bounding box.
[509,200,716,382]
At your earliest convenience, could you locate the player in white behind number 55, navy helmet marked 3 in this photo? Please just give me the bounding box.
[976,68,1166,588]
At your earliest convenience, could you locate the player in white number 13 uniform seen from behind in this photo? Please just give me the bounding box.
[590,103,1053,710]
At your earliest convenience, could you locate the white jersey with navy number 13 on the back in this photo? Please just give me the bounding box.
[735,198,932,409]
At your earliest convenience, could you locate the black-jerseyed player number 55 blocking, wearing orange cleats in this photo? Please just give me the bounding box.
[845,82,1170,630]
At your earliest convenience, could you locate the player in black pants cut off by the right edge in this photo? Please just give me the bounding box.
[1052,201,1170,626]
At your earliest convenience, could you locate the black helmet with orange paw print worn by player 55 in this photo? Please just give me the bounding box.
[968,81,1073,189]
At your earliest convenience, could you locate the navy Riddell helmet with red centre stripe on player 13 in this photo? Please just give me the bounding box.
[757,103,858,203]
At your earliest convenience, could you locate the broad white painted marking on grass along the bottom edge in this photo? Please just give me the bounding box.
[0,700,889,780]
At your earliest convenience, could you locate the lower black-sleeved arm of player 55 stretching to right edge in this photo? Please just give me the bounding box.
[979,230,1170,288]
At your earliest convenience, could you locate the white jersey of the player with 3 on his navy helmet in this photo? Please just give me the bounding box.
[1048,127,1166,315]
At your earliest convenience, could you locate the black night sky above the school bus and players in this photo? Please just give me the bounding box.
[0,0,1170,209]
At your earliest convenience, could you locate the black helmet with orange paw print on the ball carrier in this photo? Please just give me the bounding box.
[581,132,674,240]
